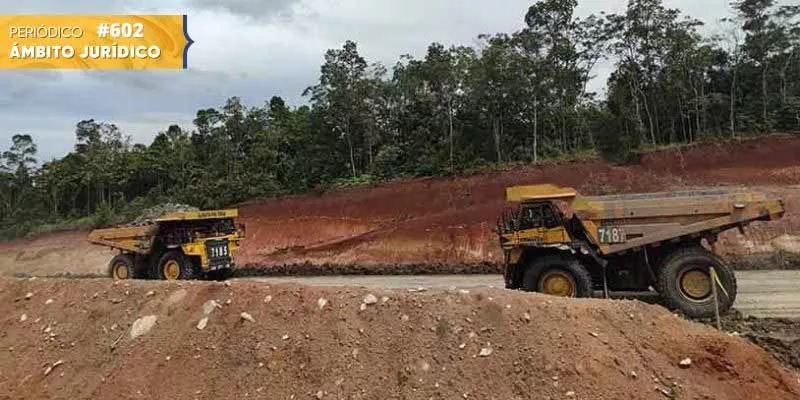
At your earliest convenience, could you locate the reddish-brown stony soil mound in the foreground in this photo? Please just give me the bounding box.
[0,279,800,400]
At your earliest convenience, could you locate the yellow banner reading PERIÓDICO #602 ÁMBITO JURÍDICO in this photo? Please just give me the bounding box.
[0,15,192,69]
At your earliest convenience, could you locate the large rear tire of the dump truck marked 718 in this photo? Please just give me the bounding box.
[656,247,737,318]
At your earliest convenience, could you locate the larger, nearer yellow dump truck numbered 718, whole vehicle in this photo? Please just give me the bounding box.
[498,185,784,317]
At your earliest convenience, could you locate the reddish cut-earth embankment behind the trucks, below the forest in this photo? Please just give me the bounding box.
[0,136,800,276]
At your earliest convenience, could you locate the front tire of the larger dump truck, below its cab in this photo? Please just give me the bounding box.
[522,255,594,297]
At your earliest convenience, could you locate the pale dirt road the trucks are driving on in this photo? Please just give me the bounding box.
[244,271,800,318]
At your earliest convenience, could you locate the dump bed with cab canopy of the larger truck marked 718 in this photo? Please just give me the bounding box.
[507,185,784,254]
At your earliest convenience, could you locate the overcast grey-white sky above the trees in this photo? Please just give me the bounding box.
[0,0,748,161]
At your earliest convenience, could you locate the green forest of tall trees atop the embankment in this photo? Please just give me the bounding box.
[0,0,800,238]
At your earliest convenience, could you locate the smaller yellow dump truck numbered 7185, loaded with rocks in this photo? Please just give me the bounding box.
[89,210,243,280]
